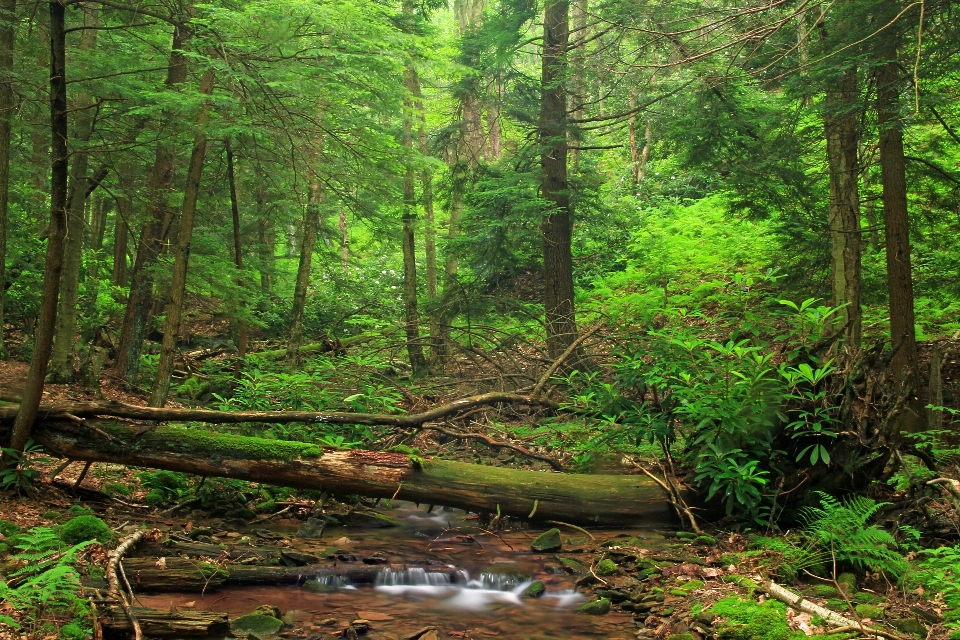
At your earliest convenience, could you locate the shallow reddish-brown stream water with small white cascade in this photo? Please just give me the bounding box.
[139,504,663,640]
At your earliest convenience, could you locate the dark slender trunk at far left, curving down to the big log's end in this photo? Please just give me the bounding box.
[10,2,70,451]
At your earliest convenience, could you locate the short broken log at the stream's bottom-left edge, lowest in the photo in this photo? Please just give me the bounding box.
[99,607,230,638]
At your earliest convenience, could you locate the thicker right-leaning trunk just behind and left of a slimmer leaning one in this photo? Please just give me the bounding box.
[115,27,190,386]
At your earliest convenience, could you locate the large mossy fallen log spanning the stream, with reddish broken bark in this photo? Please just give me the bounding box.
[33,421,669,525]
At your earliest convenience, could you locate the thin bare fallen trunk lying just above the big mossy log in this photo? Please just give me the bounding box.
[0,392,557,428]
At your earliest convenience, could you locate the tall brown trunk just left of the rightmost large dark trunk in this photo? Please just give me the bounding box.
[824,69,863,349]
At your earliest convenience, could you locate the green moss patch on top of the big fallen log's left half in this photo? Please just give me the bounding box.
[98,422,323,460]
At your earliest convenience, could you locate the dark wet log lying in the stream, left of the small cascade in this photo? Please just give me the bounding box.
[123,557,455,593]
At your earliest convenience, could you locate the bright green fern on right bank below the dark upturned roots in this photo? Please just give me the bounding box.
[801,491,908,576]
